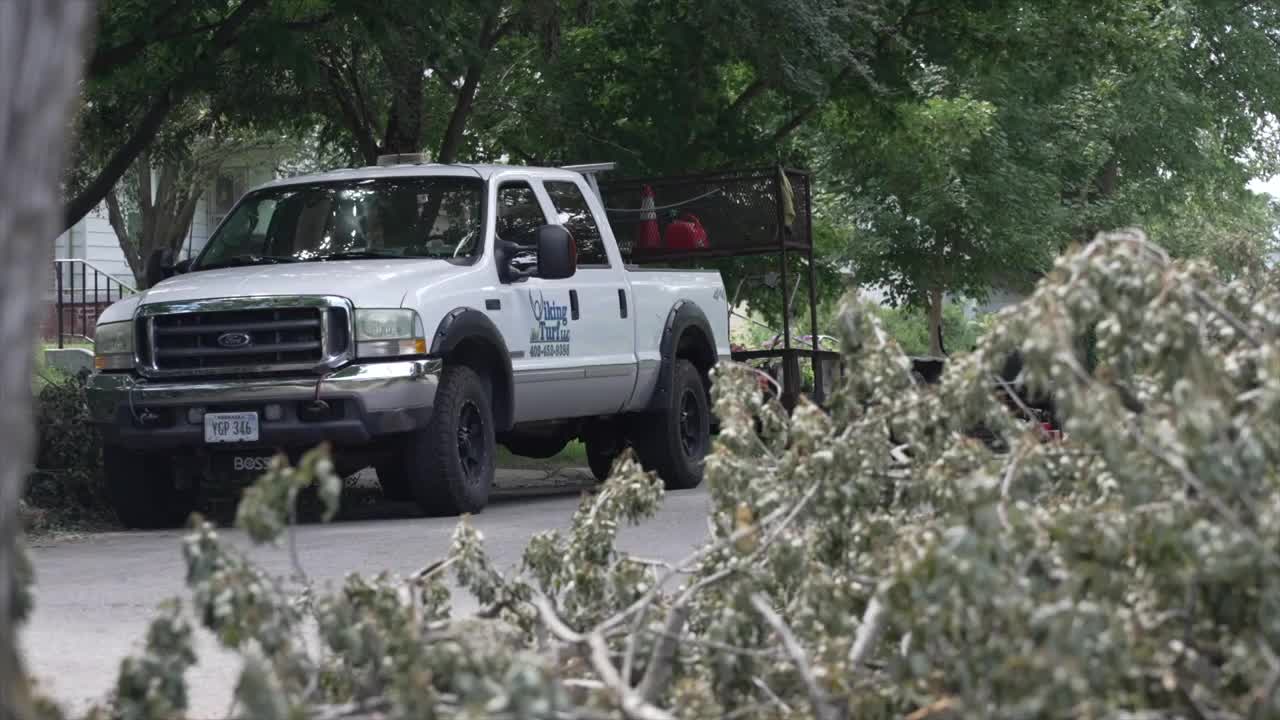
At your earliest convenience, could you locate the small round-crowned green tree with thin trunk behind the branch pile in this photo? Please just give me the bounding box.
[822,91,1066,356]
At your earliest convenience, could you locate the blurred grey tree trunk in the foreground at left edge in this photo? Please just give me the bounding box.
[0,0,95,719]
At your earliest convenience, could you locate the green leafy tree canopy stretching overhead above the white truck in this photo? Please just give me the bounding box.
[68,0,1280,338]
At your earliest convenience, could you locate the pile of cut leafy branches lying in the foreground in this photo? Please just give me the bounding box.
[24,232,1280,720]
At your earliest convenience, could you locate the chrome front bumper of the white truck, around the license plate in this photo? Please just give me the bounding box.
[87,360,442,450]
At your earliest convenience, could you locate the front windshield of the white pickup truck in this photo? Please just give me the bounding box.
[193,177,484,269]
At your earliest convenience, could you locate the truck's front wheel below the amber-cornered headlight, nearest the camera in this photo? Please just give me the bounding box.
[403,365,498,515]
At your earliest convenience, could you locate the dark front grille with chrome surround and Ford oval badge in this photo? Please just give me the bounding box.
[140,306,351,375]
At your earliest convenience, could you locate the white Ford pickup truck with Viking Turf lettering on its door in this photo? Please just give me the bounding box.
[88,161,730,527]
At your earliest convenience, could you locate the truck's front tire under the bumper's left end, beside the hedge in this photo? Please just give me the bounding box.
[102,445,196,530]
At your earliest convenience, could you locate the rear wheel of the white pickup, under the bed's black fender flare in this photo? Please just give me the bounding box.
[634,360,710,489]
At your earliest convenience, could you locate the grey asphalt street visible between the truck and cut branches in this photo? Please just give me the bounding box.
[22,471,708,719]
